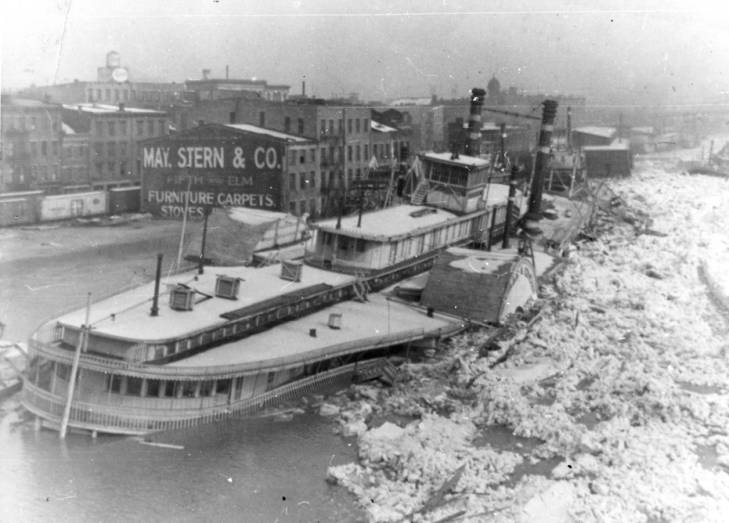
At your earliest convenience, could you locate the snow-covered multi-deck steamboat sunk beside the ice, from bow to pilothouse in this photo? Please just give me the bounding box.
[21,92,556,436]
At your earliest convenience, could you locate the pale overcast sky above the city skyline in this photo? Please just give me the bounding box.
[0,0,729,104]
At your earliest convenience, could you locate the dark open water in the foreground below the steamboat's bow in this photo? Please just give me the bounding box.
[0,396,364,522]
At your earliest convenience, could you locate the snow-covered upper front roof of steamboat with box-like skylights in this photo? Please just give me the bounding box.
[58,264,353,343]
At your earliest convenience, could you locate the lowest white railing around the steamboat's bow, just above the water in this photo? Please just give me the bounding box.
[22,358,385,434]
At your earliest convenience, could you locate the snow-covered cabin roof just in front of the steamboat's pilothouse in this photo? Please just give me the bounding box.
[314,205,456,239]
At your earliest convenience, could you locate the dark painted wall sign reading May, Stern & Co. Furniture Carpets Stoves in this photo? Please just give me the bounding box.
[141,136,285,218]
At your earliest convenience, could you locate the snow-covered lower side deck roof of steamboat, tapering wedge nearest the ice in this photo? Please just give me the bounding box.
[166,294,460,367]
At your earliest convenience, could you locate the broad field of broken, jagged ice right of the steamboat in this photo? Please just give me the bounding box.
[329,158,729,521]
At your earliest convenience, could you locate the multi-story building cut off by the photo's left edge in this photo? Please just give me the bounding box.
[0,95,62,191]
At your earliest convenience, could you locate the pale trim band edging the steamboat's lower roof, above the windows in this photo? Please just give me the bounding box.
[30,324,461,381]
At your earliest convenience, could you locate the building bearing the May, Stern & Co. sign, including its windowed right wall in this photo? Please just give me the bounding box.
[139,124,321,218]
